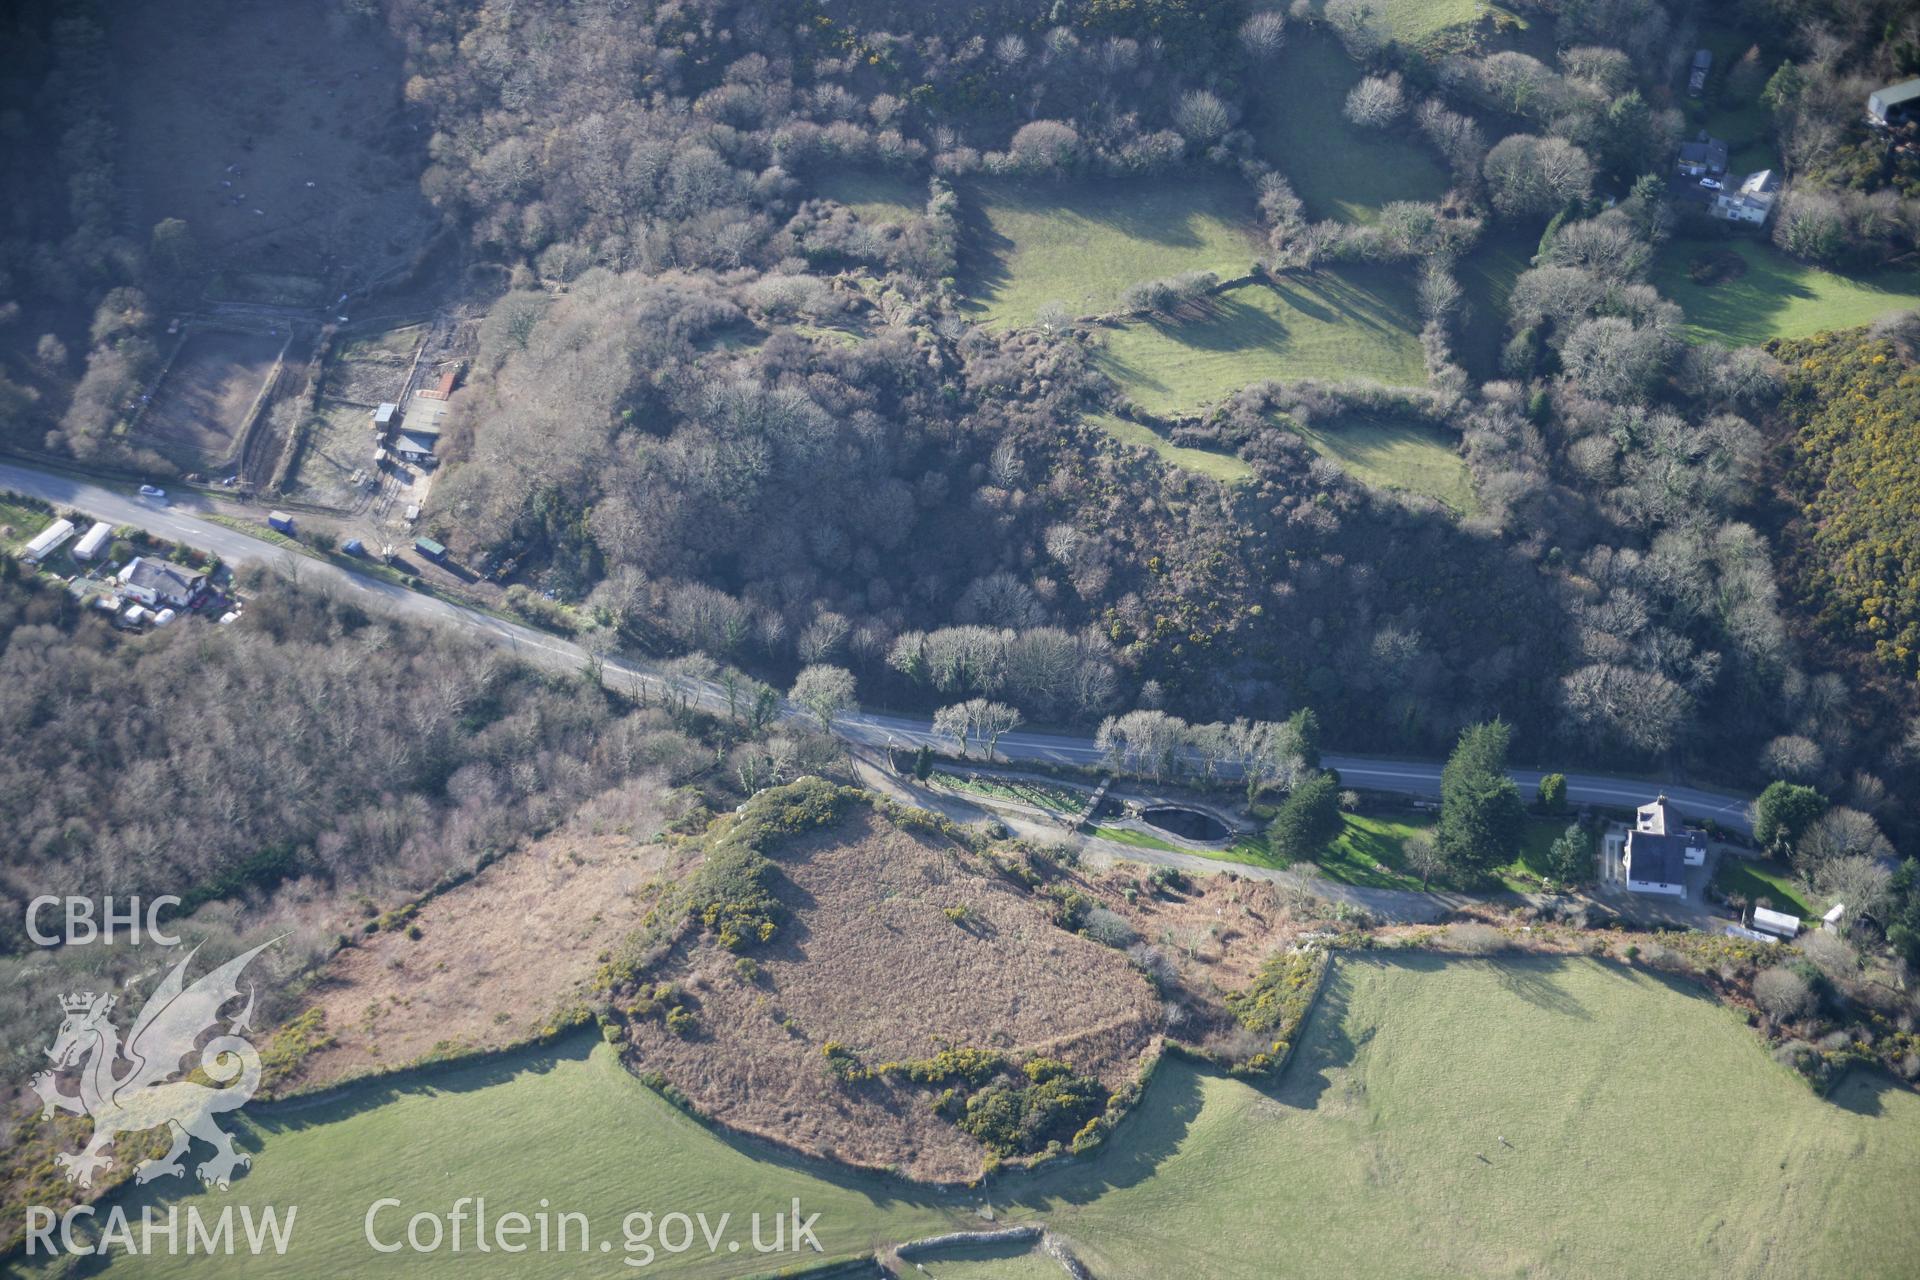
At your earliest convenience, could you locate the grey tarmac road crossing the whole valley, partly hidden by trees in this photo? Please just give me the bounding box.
[0,454,1749,831]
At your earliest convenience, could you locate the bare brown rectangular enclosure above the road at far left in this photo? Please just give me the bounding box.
[132,328,292,472]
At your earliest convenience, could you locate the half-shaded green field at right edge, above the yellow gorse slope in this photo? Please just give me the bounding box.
[1653,236,1920,347]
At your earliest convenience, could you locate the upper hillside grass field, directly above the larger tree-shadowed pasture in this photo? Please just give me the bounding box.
[960,173,1260,326]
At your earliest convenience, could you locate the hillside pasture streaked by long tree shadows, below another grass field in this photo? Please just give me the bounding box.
[1096,265,1427,415]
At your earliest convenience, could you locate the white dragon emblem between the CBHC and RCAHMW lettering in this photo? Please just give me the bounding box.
[33,938,278,1190]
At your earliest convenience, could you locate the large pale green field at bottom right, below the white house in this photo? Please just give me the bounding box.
[1000,954,1920,1280]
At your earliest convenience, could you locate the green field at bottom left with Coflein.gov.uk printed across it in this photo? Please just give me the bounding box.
[48,1036,968,1280]
